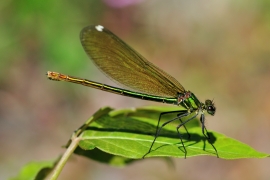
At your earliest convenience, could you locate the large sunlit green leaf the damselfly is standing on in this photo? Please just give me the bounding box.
[75,107,269,160]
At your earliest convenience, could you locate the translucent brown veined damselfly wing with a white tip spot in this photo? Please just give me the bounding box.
[80,25,185,97]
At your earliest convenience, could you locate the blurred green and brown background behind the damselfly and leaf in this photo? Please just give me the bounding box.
[0,0,270,180]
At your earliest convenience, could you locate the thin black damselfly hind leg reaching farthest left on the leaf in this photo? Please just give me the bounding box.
[142,110,189,158]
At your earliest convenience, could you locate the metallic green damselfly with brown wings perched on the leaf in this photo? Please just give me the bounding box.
[47,25,218,158]
